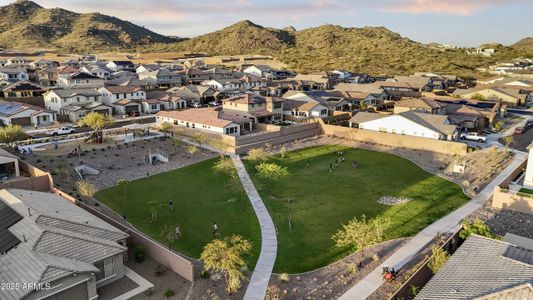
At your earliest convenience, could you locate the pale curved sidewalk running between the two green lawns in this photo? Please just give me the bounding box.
[230,154,278,300]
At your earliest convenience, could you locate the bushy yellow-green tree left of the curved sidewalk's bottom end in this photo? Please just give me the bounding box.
[200,235,252,294]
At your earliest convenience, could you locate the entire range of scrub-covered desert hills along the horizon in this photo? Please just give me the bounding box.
[0,0,533,76]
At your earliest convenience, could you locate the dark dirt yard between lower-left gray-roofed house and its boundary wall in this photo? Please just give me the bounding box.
[126,257,192,300]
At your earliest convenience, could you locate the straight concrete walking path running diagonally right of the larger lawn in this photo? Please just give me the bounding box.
[339,151,527,300]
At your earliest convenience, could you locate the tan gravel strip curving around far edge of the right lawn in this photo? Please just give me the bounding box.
[280,136,513,197]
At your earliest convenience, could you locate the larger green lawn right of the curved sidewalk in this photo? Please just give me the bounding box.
[246,146,469,273]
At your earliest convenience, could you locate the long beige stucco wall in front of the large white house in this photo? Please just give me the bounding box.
[319,121,468,155]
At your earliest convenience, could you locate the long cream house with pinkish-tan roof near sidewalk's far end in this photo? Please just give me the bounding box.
[156,107,245,136]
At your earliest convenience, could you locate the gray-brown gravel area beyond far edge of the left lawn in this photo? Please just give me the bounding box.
[22,138,218,196]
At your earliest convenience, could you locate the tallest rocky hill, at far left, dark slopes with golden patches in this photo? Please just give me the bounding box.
[0,0,175,52]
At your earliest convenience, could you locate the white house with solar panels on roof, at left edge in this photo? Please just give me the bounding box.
[0,100,56,126]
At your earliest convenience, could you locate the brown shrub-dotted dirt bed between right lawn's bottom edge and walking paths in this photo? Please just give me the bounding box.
[265,238,409,300]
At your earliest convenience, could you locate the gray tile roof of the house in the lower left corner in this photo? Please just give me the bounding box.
[0,189,128,300]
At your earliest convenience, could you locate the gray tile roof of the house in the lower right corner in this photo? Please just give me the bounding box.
[415,235,533,300]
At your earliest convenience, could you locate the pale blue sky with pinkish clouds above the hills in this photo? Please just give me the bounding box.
[5,0,533,47]
